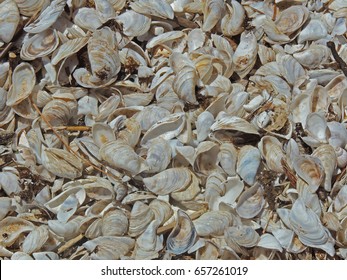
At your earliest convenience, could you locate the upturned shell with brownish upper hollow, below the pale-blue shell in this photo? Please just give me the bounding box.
[236,184,265,219]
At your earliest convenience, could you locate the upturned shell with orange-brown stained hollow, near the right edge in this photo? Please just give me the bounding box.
[293,155,325,192]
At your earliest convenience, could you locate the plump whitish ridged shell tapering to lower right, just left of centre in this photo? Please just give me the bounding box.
[99,140,147,174]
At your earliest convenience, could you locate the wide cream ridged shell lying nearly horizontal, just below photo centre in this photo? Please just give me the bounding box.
[143,167,192,195]
